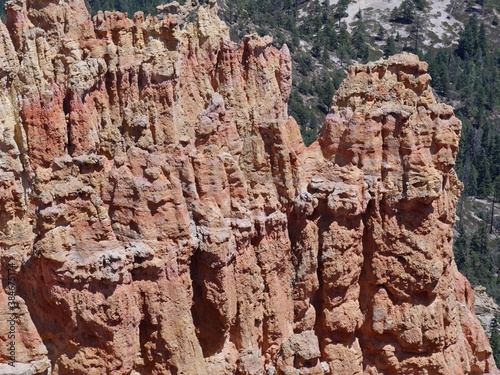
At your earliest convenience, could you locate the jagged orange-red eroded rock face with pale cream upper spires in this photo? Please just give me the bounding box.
[0,0,498,375]
